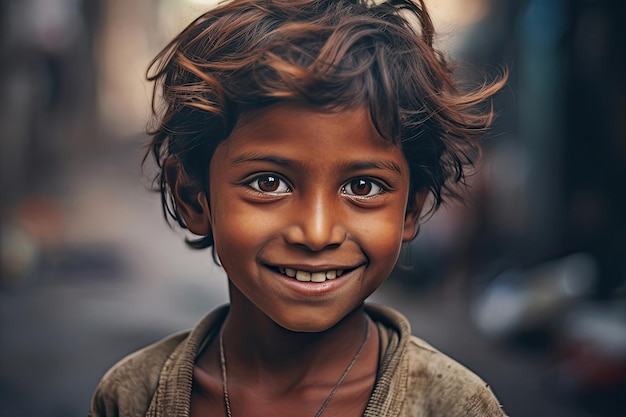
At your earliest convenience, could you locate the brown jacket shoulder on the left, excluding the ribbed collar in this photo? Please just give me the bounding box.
[89,332,189,417]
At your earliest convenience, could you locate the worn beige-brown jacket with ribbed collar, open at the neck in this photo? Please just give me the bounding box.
[89,304,505,417]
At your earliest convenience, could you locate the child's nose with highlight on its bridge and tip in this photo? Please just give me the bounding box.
[285,195,347,251]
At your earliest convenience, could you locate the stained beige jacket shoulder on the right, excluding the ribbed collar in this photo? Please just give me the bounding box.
[407,336,505,417]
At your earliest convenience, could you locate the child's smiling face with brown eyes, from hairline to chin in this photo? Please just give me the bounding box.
[204,103,423,331]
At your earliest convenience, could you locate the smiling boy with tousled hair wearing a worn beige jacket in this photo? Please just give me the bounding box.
[90,0,504,417]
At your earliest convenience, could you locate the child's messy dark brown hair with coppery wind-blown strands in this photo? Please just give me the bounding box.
[146,0,505,248]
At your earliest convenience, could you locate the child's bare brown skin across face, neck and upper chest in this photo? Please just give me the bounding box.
[167,103,426,416]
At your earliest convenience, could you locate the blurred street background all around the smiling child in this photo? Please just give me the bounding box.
[0,0,626,417]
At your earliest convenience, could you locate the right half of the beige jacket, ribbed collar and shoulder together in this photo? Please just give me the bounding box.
[366,304,505,417]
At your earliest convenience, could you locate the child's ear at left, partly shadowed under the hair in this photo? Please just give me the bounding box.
[163,156,211,236]
